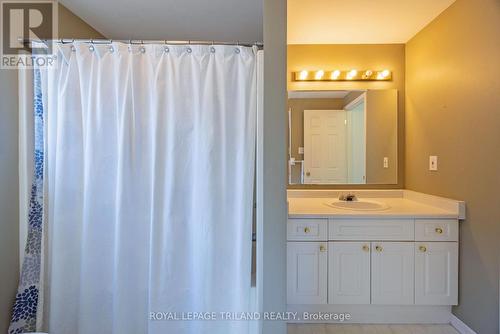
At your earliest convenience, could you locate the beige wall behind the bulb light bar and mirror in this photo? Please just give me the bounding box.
[287,44,405,188]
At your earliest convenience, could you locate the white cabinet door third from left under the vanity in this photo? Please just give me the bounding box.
[371,242,415,305]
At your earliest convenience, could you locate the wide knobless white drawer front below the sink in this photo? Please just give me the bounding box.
[328,219,415,241]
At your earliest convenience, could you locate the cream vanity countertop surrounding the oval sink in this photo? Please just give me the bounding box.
[288,190,465,219]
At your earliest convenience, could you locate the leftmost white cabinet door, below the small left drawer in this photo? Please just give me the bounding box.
[287,242,328,304]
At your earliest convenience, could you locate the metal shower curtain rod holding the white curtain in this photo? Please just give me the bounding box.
[18,38,264,49]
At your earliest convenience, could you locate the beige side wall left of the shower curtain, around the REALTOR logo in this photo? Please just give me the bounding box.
[0,5,102,333]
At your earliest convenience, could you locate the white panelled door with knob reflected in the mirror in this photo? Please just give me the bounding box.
[304,110,347,183]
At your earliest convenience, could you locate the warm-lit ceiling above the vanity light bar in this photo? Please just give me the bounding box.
[288,0,455,44]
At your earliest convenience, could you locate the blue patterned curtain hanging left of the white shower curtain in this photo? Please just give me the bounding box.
[9,70,44,334]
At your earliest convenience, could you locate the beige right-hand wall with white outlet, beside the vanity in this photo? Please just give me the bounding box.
[406,0,500,334]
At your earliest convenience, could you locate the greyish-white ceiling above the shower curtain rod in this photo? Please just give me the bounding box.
[60,0,263,42]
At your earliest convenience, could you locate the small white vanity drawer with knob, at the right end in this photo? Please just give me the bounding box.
[415,219,458,241]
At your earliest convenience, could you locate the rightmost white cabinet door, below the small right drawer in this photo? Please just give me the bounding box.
[415,242,458,305]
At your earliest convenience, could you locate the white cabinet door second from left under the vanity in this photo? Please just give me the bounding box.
[328,241,370,304]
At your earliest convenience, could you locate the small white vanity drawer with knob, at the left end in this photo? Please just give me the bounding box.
[286,218,328,241]
